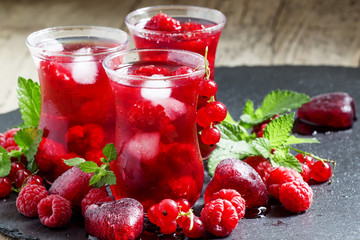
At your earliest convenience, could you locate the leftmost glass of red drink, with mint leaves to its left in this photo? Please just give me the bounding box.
[27,26,129,182]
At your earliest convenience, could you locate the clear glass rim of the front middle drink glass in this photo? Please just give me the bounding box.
[102,48,205,82]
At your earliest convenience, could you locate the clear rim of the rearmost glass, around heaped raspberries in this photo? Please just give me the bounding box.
[125,5,226,36]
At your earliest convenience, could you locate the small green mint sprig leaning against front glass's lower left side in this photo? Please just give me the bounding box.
[64,143,117,188]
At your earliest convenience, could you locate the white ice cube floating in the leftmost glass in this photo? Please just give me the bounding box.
[70,48,98,84]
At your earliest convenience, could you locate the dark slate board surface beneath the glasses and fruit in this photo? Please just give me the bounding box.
[0,66,360,240]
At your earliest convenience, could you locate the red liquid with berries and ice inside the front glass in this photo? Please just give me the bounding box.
[111,61,204,210]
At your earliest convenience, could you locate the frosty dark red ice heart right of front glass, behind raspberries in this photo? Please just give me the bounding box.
[204,159,268,208]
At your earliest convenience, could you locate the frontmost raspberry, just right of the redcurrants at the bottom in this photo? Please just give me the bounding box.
[201,199,239,237]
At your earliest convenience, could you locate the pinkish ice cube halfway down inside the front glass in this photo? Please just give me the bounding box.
[125,132,160,161]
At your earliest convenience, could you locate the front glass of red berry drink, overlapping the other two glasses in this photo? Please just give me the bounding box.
[104,49,204,210]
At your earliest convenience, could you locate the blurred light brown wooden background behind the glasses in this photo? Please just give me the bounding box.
[0,0,360,239]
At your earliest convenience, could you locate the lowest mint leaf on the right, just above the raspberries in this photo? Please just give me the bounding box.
[270,147,302,172]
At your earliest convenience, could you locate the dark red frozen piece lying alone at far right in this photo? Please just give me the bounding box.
[298,92,356,128]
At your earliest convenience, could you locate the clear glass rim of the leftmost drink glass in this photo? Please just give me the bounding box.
[25,25,130,57]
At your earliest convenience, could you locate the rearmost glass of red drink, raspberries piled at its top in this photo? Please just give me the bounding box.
[125,5,226,159]
